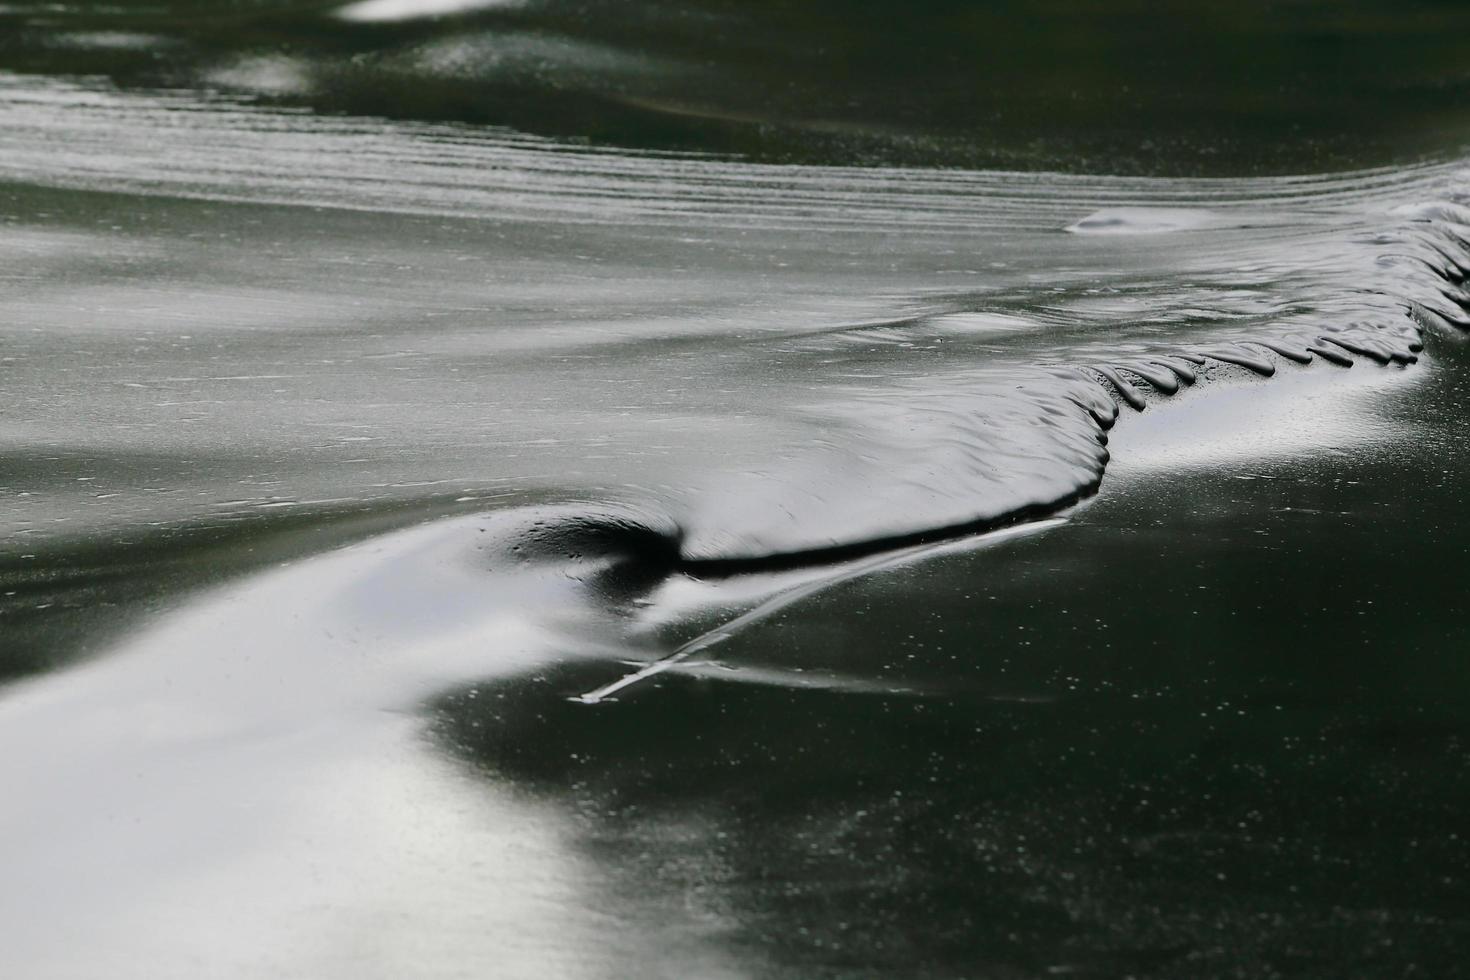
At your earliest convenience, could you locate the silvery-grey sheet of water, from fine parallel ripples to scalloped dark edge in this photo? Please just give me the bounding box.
[0,78,1470,561]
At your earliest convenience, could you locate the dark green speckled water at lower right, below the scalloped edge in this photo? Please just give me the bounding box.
[437,358,1470,977]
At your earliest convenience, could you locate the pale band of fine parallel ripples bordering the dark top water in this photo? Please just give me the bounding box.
[0,71,1454,227]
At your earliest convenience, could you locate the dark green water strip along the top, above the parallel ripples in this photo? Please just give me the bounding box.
[0,0,1470,175]
